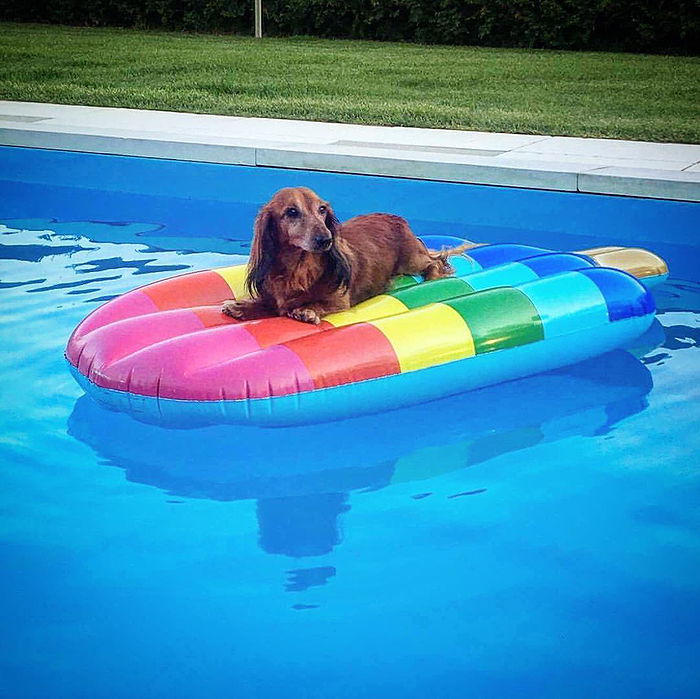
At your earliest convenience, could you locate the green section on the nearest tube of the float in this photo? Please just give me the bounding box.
[443,287,544,354]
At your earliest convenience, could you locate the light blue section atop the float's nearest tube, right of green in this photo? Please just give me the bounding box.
[519,272,610,339]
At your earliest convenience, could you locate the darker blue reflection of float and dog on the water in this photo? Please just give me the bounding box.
[68,344,659,591]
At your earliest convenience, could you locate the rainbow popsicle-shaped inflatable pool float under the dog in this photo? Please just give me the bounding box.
[66,241,667,425]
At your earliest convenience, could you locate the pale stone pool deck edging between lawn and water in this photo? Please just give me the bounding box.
[0,101,700,202]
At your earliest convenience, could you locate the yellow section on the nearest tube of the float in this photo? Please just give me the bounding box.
[372,303,475,371]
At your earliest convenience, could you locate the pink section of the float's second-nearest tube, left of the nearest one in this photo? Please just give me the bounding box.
[104,325,260,400]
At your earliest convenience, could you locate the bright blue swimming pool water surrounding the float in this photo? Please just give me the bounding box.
[0,148,700,699]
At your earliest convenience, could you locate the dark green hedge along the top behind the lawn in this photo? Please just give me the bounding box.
[0,0,700,54]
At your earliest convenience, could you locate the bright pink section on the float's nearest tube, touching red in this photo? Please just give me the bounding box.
[189,345,314,400]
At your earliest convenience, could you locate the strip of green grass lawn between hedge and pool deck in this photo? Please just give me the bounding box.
[0,24,700,143]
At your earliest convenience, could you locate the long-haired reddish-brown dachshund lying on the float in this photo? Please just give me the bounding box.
[221,187,473,323]
